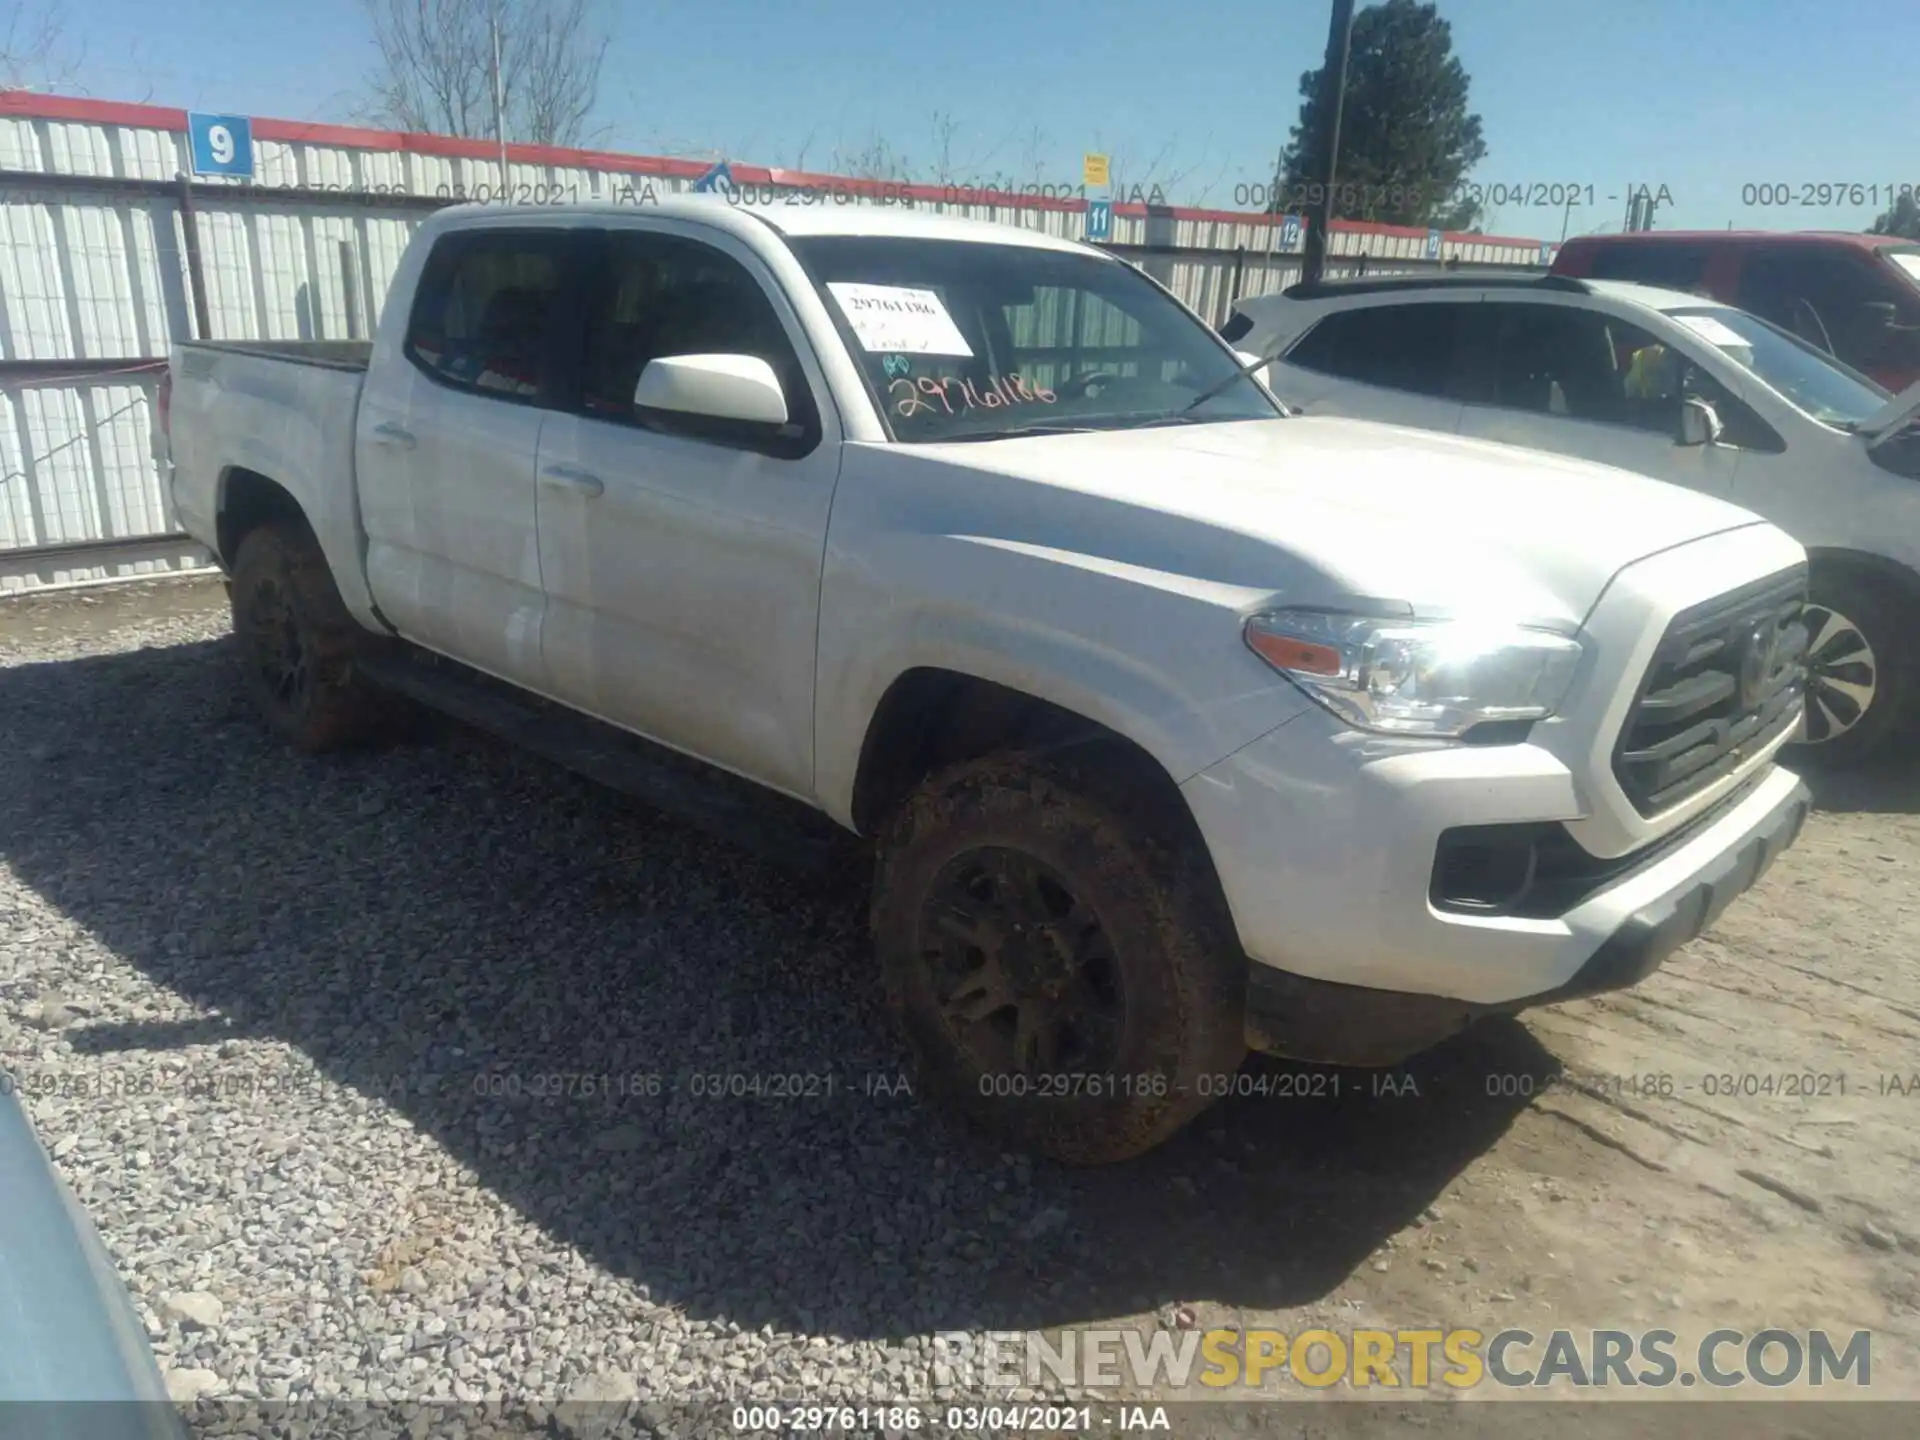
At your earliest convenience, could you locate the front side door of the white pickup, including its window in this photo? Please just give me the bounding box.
[538,228,839,795]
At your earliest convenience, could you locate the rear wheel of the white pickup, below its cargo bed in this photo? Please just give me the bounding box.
[228,520,392,755]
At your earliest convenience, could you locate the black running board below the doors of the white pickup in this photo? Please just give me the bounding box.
[355,641,858,874]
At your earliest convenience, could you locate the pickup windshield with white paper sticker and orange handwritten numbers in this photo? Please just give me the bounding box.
[793,236,1281,444]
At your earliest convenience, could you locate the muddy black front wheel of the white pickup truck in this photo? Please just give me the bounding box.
[874,755,1246,1165]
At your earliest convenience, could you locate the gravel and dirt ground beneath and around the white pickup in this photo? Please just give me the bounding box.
[0,582,1920,1434]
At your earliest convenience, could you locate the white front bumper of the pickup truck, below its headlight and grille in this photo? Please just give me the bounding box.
[1183,710,1807,1012]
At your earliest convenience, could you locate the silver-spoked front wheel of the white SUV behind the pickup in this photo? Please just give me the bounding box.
[1795,570,1912,766]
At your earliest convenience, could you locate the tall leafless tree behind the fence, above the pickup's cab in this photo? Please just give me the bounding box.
[365,0,607,146]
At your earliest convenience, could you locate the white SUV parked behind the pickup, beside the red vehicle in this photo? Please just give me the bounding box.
[1221,275,1920,762]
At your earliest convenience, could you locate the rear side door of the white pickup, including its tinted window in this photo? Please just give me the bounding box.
[355,230,566,687]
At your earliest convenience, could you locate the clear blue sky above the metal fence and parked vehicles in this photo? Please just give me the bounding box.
[52,0,1920,240]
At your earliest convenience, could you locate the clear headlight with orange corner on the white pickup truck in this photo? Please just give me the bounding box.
[1246,611,1580,735]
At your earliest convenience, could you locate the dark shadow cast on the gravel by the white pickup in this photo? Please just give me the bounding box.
[0,643,1557,1338]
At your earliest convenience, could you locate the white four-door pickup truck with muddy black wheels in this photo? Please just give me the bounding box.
[159,198,1809,1164]
